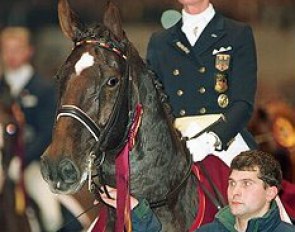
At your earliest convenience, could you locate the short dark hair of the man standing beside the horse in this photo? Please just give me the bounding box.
[230,150,282,189]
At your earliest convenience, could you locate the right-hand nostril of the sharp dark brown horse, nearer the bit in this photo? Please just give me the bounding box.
[58,159,79,184]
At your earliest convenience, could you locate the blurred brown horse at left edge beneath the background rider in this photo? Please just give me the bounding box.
[0,93,32,232]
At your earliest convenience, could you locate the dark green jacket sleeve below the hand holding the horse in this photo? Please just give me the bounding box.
[131,199,162,232]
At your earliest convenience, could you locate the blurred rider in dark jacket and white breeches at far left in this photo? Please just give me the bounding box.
[0,27,62,231]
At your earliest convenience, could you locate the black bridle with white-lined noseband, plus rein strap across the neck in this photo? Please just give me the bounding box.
[56,39,192,208]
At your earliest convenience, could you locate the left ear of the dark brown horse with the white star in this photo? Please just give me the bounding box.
[58,0,80,41]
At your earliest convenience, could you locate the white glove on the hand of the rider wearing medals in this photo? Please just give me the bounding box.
[186,132,220,162]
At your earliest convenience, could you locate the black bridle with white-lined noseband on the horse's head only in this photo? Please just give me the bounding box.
[56,39,133,196]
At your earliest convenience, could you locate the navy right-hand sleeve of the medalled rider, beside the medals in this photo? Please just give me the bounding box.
[212,26,257,148]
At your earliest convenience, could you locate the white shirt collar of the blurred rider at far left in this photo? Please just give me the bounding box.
[4,64,34,97]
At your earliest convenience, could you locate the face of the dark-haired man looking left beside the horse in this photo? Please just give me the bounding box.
[227,170,277,219]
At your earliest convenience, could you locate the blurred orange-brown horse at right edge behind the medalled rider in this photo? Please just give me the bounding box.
[249,100,295,183]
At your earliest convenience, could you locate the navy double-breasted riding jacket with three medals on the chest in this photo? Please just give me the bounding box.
[147,13,257,149]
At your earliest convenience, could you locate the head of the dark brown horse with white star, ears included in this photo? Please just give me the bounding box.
[42,0,149,193]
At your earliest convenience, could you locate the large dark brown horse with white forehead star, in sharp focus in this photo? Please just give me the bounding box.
[41,0,204,232]
